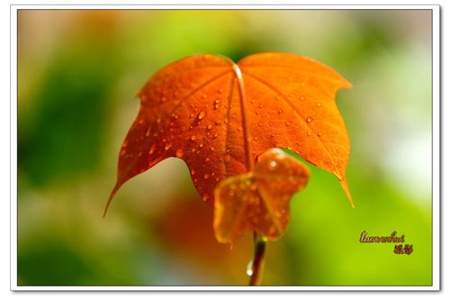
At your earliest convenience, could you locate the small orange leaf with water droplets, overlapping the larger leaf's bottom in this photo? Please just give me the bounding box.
[214,148,309,243]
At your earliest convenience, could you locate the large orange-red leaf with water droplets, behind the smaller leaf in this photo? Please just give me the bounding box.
[105,53,351,216]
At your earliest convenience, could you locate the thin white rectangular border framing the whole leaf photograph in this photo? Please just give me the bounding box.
[10,4,441,291]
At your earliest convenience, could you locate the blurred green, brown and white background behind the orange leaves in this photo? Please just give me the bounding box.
[18,10,432,285]
